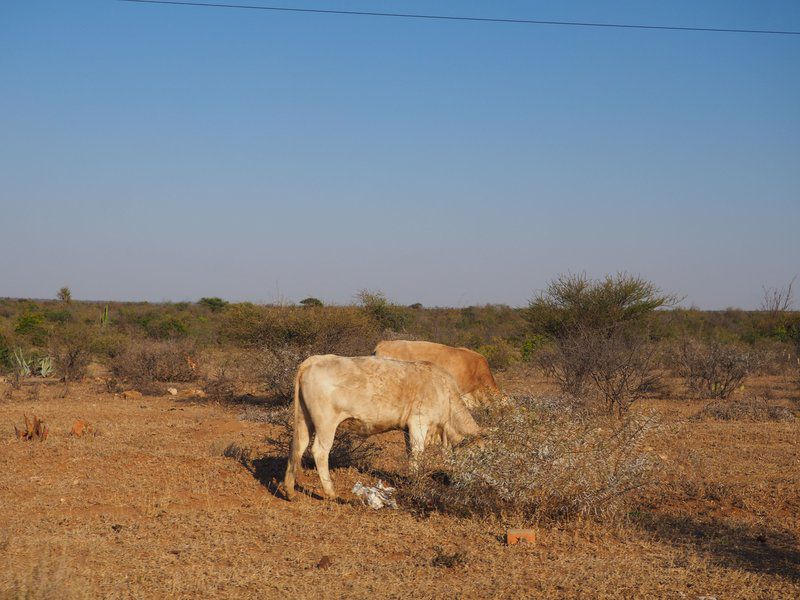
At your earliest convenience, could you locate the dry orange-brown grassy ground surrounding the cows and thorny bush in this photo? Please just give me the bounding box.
[0,370,800,598]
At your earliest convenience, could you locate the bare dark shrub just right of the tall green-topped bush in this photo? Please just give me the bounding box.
[671,337,757,399]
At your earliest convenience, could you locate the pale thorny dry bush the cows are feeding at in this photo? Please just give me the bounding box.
[399,397,662,521]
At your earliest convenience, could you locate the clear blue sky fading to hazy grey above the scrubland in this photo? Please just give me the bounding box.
[0,0,800,308]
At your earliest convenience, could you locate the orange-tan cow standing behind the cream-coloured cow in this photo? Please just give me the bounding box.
[374,340,502,408]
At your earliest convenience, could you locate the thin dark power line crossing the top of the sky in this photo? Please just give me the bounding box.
[119,0,800,35]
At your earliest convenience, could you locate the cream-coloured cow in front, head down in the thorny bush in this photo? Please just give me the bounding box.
[284,354,479,499]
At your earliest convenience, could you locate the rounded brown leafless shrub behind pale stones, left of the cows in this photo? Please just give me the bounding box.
[111,340,197,394]
